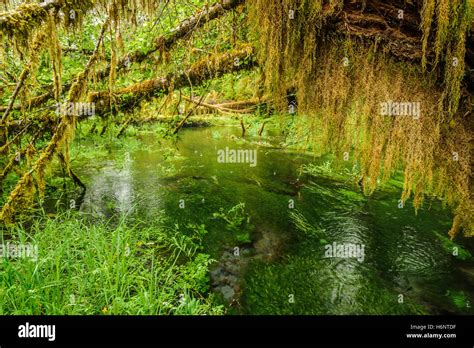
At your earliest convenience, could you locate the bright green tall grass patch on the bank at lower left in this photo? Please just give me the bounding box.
[0,216,223,315]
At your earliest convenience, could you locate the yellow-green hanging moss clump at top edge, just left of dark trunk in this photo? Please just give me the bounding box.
[248,0,343,107]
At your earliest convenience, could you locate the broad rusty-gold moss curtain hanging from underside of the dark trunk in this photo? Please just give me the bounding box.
[308,38,473,236]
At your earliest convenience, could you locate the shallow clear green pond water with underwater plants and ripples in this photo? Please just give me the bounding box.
[52,127,474,314]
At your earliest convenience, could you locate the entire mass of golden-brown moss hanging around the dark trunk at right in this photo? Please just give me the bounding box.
[249,0,474,237]
